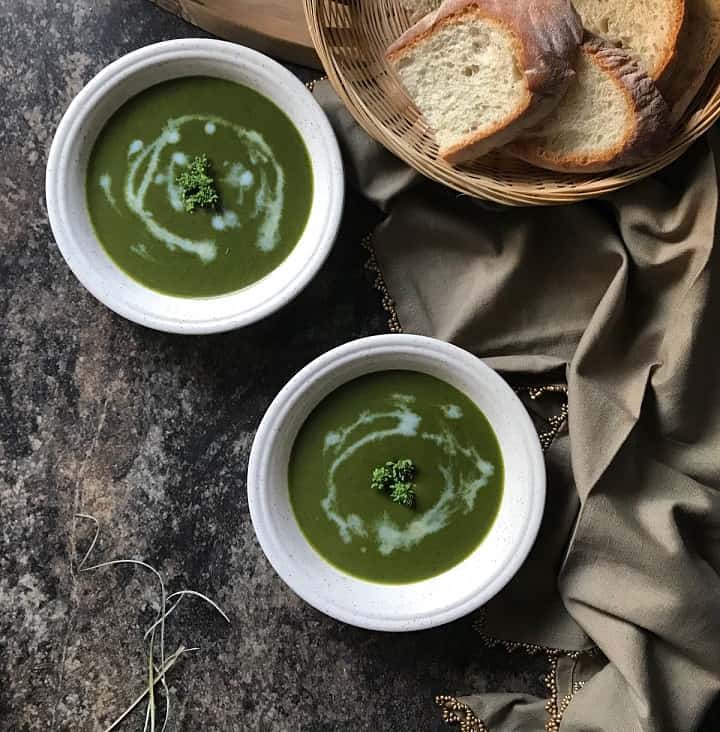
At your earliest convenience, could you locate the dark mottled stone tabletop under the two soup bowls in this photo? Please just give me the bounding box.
[0,0,544,732]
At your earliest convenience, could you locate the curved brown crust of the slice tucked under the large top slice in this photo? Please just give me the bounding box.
[507,36,670,173]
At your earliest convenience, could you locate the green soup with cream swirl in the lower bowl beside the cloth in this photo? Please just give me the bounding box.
[288,371,503,584]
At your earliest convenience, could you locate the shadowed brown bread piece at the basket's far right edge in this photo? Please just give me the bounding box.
[658,0,720,122]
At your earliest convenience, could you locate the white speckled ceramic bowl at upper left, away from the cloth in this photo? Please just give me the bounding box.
[46,39,344,333]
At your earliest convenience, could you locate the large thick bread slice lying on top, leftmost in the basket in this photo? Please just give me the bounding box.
[387,0,582,164]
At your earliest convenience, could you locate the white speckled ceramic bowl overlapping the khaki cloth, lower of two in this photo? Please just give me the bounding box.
[247,335,545,631]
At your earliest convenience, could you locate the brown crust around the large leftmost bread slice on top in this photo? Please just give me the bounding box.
[387,0,583,165]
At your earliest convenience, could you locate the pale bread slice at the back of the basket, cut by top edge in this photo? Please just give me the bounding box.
[573,0,685,80]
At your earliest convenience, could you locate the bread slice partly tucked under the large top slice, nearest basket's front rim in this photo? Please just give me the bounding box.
[507,38,670,173]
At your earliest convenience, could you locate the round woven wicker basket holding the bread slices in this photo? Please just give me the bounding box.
[303,0,720,206]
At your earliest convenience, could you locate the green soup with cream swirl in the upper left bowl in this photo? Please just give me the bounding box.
[86,76,313,297]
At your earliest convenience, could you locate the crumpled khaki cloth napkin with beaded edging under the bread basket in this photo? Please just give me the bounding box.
[315,82,720,732]
